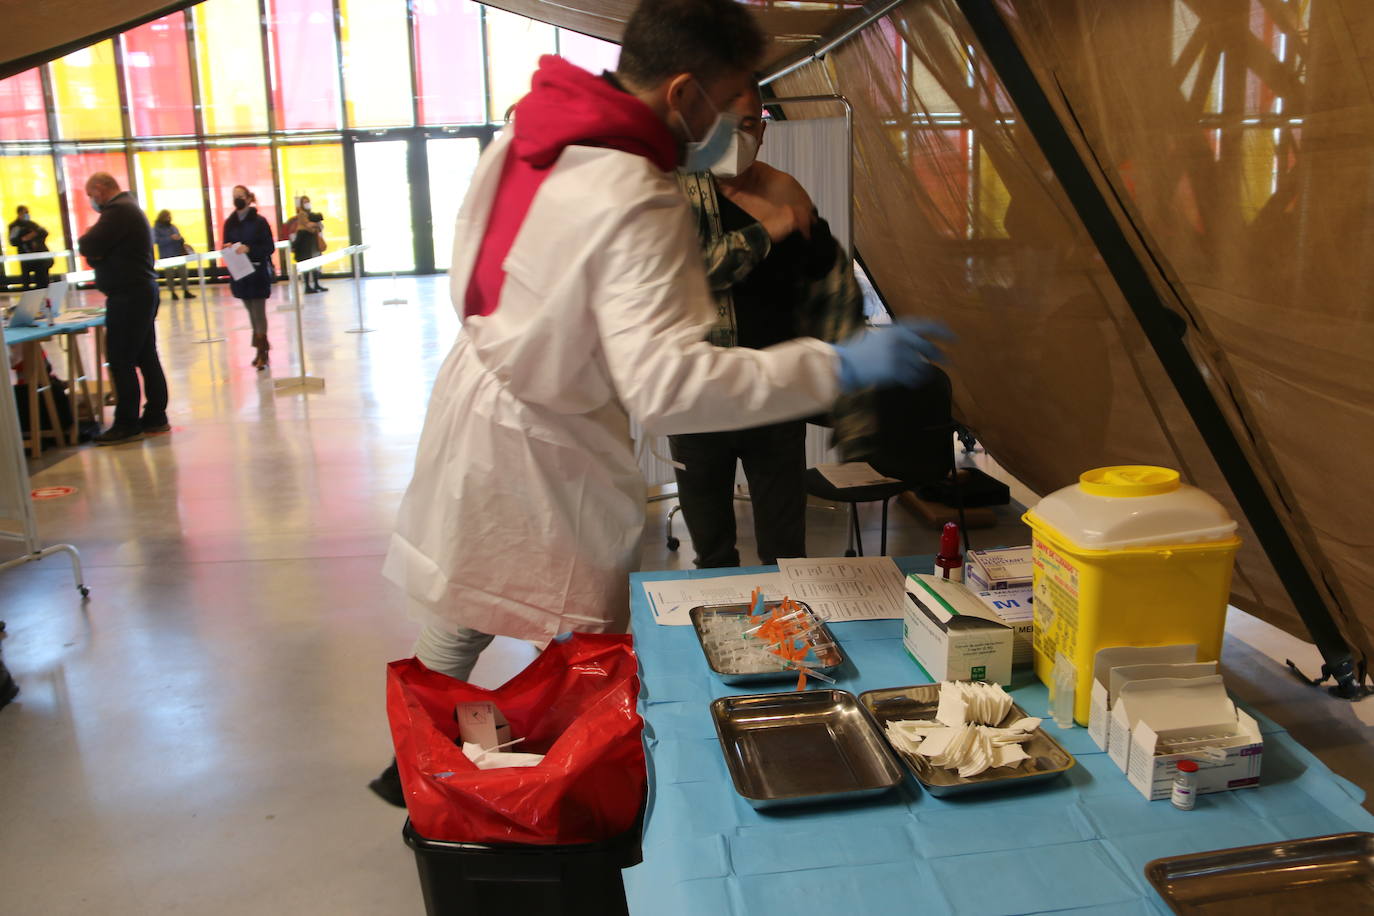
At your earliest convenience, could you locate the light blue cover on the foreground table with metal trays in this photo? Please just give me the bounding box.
[624,558,1374,916]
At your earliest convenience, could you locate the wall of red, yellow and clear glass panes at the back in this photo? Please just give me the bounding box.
[0,0,618,272]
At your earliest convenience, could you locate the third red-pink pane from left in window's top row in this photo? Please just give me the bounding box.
[268,0,342,130]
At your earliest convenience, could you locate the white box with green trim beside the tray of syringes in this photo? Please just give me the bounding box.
[901,573,1014,684]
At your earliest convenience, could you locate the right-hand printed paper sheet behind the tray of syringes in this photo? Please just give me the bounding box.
[778,556,907,621]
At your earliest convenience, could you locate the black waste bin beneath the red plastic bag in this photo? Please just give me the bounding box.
[401,818,642,916]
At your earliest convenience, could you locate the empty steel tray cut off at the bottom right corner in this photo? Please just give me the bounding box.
[1145,834,1374,916]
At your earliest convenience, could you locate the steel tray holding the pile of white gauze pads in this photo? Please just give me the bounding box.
[859,684,1077,798]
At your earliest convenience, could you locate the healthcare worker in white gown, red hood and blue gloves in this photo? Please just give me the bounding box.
[385,0,934,680]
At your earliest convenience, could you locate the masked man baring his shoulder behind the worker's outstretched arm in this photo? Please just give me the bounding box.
[668,87,864,569]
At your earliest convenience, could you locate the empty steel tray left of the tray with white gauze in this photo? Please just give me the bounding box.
[710,689,901,808]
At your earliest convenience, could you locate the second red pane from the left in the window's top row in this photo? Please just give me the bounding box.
[121,12,195,137]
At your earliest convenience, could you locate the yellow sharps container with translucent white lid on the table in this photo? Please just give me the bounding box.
[1024,466,1241,725]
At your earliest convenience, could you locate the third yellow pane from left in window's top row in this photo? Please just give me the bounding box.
[339,0,415,128]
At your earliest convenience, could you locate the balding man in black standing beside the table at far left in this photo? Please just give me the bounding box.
[77,172,172,445]
